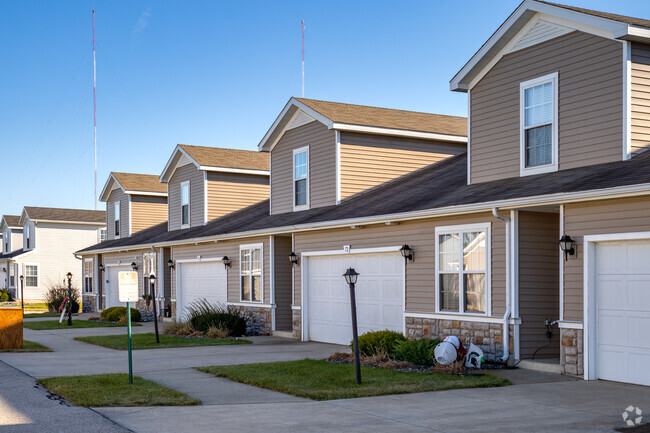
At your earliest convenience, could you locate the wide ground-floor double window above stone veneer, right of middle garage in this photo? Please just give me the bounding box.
[436,225,490,314]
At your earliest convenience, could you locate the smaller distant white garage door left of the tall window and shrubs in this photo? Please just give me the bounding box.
[176,261,228,318]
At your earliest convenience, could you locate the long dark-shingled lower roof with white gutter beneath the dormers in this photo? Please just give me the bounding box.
[81,152,650,252]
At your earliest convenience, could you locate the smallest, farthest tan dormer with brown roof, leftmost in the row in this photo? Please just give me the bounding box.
[99,172,167,240]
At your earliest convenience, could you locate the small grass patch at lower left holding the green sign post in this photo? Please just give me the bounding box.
[38,373,201,407]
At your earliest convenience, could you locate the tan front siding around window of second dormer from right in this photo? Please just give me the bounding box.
[271,122,336,214]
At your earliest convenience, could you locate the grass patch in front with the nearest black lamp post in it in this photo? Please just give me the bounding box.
[197,359,510,400]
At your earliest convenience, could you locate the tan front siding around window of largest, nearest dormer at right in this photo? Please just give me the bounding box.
[470,32,623,183]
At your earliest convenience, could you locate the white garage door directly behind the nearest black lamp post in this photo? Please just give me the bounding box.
[305,252,404,344]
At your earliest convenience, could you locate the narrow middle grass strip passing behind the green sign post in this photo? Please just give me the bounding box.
[75,333,251,350]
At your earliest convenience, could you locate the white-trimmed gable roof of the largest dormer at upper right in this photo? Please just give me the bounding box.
[449,0,650,92]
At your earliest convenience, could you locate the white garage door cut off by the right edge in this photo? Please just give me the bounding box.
[596,241,650,385]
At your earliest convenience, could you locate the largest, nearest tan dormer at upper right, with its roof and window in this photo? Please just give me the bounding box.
[450,0,650,184]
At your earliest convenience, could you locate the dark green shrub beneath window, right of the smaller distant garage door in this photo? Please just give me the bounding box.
[186,299,246,337]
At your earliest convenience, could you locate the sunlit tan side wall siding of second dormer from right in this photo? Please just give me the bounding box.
[341,132,465,200]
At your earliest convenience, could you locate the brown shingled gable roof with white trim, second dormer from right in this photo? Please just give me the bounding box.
[258,98,467,151]
